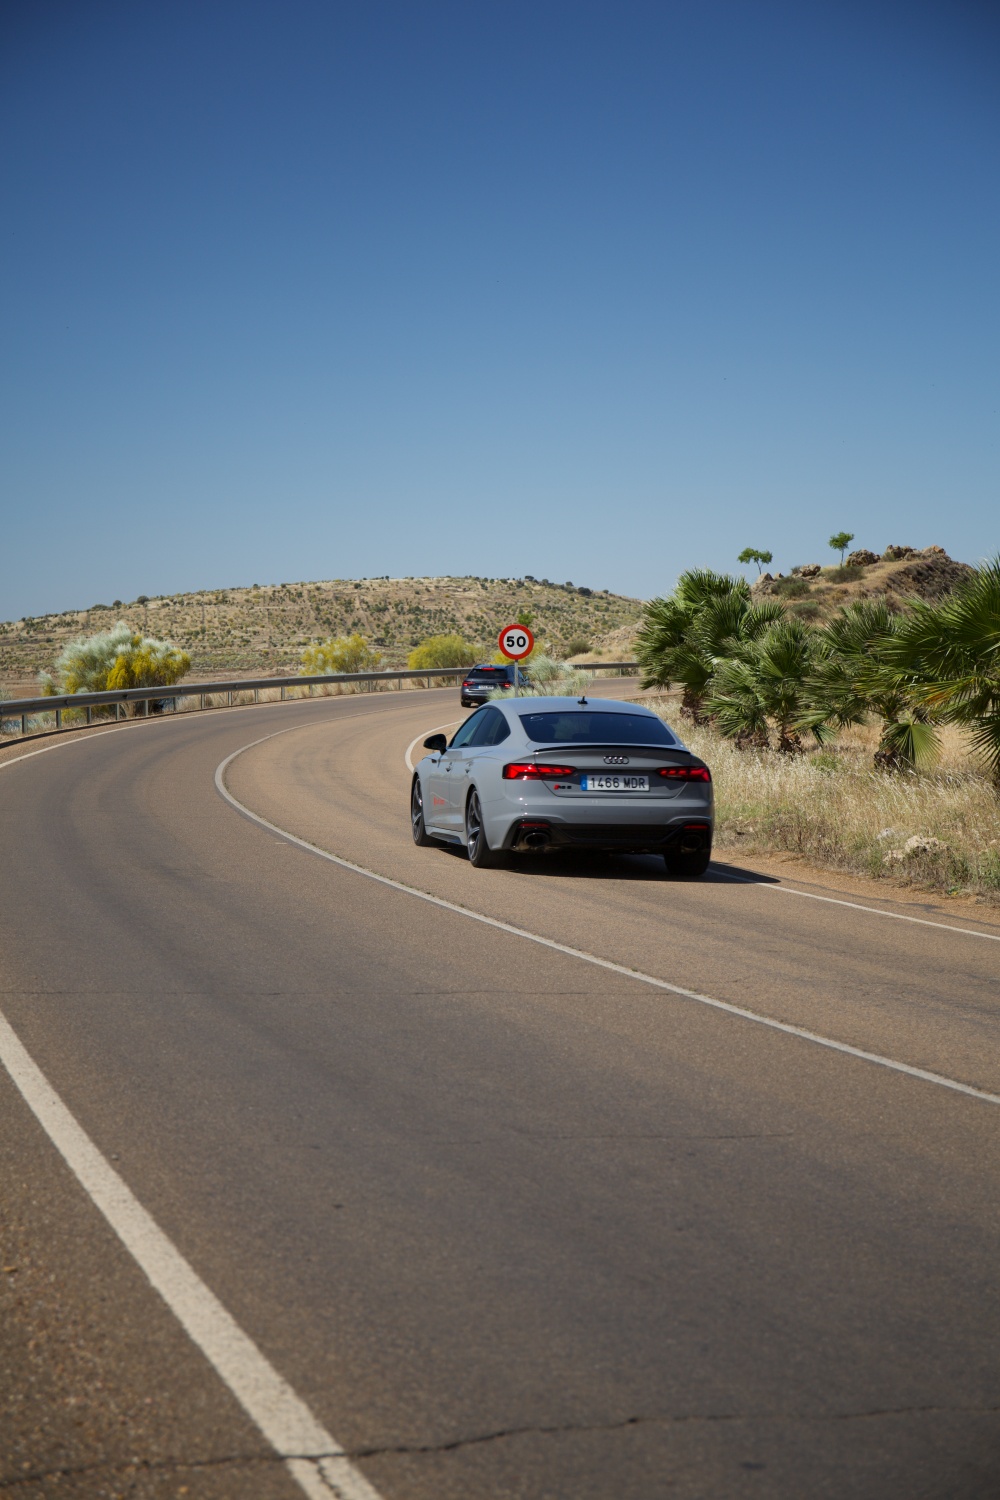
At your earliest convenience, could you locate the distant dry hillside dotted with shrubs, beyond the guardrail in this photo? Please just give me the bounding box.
[0,578,642,690]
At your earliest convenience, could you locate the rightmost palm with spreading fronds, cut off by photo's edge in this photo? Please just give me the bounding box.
[891,557,1000,791]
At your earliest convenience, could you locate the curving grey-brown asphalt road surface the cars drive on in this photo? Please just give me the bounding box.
[0,692,1000,1500]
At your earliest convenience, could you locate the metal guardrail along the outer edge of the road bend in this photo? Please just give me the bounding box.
[0,662,639,740]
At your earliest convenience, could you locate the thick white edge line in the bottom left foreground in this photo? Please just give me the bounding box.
[0,1008,379,1500]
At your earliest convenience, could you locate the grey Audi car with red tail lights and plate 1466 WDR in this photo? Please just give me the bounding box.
[411,698,714,878]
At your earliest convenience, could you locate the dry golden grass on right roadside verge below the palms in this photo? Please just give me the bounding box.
[645,695,1000,905]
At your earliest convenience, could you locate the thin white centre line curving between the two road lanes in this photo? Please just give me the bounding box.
[216,731,1000,1104]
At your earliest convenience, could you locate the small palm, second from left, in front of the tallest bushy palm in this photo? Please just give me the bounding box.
[705,620,832,755]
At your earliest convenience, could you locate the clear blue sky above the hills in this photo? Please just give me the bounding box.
[0,0,1000,618]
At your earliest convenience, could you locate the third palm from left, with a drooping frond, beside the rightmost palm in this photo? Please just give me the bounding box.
[813,599,940,771]
